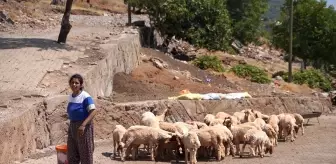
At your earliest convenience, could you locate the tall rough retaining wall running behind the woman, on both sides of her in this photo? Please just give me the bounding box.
[0,34,140,164]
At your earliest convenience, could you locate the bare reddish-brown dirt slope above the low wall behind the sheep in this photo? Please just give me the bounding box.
[112,48,318,102]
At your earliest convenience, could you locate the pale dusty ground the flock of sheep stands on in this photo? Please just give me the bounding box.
[18,115,336,164]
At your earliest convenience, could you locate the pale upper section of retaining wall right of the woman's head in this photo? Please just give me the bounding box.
[84,34,140,97]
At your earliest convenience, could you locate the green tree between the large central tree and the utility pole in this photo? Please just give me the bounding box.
[227,0,268,43]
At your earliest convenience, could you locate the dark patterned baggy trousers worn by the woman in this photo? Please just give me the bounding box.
[67,121,94,164]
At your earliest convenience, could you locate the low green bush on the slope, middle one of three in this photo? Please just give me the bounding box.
[231,64,271,84]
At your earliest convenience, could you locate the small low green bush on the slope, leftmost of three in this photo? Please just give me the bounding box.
[193,55,224,72]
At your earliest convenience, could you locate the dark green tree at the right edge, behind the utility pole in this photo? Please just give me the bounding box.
[272,0,336,68]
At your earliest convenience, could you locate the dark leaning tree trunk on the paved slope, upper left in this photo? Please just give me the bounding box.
[57,0,73,43]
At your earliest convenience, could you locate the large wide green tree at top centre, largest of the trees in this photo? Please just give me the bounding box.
[129,0,232,50]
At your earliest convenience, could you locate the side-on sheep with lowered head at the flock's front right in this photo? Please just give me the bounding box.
[240,129,273,158]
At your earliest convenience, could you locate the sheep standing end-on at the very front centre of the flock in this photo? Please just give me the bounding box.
[182,131,201,164]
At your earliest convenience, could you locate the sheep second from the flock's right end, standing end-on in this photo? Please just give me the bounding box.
[279,114,298,142]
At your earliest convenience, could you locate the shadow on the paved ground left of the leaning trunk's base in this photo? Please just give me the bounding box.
[0,38,75,51]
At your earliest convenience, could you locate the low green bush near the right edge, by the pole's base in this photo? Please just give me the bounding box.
[283,69,332,91]
